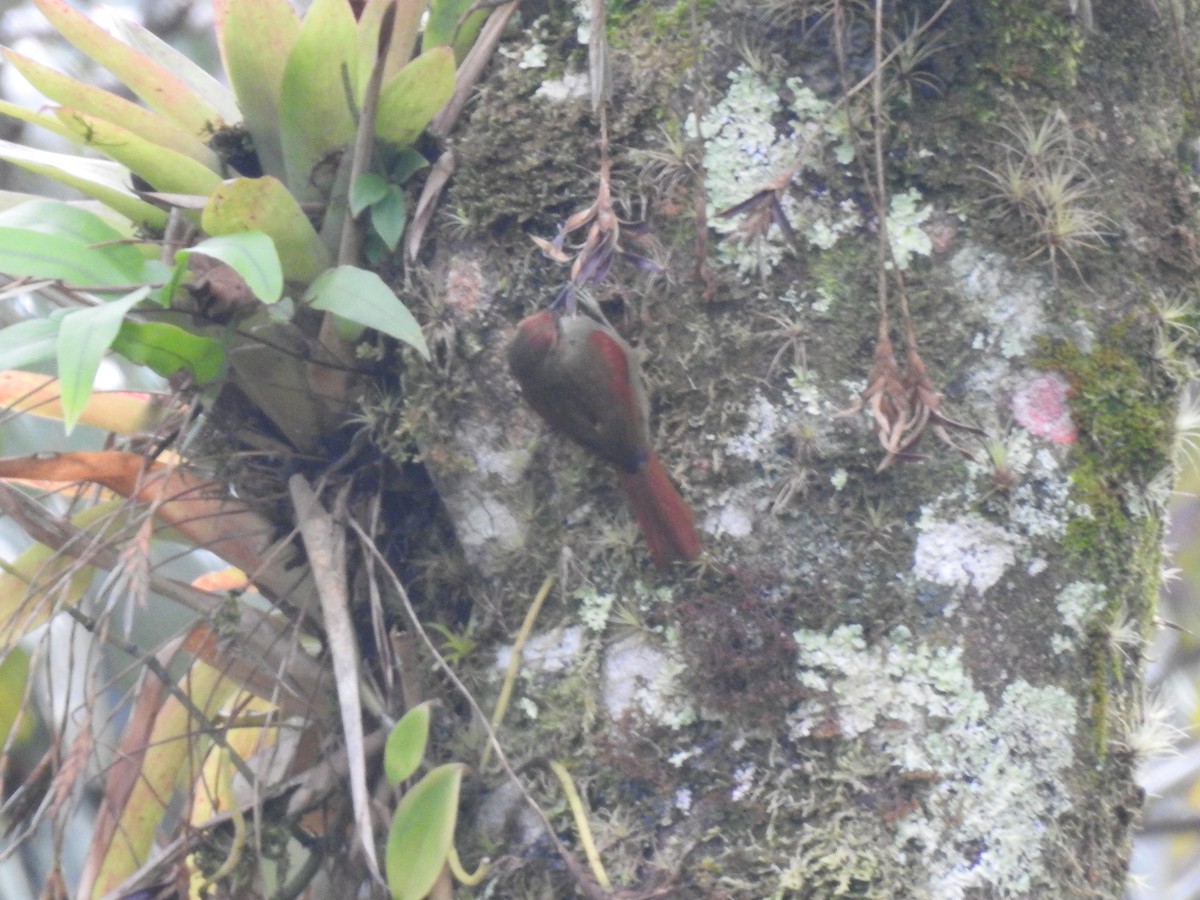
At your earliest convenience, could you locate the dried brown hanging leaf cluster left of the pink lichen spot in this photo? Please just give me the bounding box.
[839,335,983,472]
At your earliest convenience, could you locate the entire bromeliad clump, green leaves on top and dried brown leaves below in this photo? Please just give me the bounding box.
[0,0,515,896]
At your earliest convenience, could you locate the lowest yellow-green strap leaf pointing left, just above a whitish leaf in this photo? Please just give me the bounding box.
[54,107,221,194]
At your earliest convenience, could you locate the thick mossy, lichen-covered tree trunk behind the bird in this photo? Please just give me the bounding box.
[412,0,1200,898]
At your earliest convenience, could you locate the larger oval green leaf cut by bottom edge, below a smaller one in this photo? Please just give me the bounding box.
[385,762,463,900]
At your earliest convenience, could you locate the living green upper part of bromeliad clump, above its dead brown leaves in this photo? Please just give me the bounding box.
[0,0,496,449]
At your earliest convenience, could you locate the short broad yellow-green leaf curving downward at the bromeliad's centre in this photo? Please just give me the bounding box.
[200,176,330,282]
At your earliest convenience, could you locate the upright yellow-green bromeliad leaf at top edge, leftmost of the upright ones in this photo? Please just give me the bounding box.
[212,0,302,178]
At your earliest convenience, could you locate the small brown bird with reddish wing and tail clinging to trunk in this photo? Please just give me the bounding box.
[509,300,700,568]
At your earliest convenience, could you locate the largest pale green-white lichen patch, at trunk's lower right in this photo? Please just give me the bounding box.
[791,625,1078,900]
